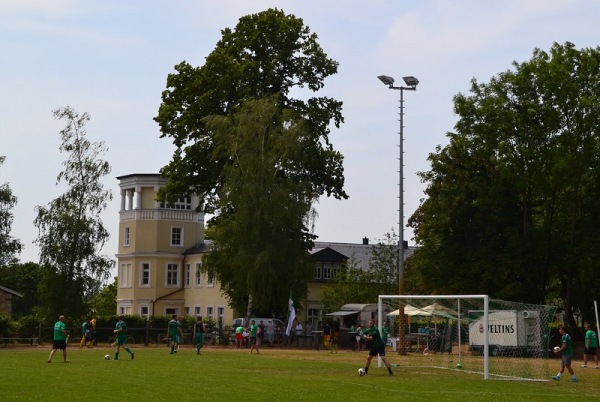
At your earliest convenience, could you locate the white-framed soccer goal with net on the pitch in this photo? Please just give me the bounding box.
[378,295,556,381]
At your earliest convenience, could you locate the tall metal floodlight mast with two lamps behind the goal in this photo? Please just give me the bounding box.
[377,75,419,354]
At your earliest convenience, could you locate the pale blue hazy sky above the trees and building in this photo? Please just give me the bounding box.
[0,0,600,278]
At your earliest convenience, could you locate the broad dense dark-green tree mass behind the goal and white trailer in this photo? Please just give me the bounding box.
[409,43,600,322]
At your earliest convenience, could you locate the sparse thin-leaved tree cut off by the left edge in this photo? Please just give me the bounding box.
[0,156,22,268]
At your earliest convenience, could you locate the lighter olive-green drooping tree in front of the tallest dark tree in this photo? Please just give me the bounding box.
[205,97,317,315]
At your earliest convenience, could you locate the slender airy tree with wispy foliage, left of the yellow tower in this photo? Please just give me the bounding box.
[34,107,113,319]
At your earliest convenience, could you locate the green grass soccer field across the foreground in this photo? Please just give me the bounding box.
[0,346,600,402]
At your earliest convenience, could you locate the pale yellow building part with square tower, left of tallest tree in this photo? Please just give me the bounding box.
[116,174,234,325]
